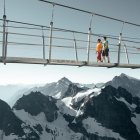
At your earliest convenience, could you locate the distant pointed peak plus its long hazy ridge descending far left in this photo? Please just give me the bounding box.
[8,77,86,106]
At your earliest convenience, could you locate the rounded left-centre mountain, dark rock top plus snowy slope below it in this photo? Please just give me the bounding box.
[13,92,82,140]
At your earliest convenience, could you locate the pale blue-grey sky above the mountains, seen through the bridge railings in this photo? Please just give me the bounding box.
[0,0,140,85]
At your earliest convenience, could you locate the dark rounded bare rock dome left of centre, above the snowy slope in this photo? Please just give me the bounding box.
[13,92,58,122]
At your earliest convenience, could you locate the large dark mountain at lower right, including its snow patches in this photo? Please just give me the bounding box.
[69,86,140,140]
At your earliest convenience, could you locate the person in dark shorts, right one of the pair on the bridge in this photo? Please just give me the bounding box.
[102,37,110,63]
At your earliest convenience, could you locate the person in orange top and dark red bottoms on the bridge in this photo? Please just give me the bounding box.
[96,39,103,62]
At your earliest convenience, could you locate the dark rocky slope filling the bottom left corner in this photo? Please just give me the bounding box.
[0,100,39,140]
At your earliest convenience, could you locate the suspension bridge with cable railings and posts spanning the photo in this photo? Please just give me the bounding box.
[0,0,140,69]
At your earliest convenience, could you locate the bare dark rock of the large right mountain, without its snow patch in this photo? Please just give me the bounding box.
[71,86,140,140]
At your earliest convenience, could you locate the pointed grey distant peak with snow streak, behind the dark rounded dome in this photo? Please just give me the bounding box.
[22,77,88,99]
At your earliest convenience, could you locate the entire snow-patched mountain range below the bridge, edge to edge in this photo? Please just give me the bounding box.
[0,74,140,140]
